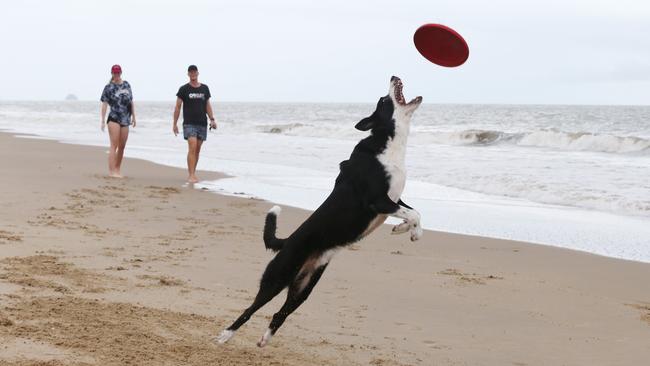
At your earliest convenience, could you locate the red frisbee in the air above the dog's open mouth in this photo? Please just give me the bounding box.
[413,24,469,67]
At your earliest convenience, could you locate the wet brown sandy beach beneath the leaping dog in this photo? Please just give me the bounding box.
[0,134,650,366]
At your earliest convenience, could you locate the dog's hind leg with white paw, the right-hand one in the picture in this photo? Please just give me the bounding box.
[257,256,328,347]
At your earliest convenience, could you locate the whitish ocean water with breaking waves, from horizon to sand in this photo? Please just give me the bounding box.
[0,101,650,262]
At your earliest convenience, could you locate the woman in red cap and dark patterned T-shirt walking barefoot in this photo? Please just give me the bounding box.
[101,65,135,178]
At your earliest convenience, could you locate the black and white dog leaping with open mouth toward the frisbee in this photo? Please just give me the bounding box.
[216,76,422,347]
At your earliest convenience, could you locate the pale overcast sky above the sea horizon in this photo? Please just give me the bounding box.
[0,0,650,105]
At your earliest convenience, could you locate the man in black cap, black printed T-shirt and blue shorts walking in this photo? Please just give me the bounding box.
[173,65,217,183]
